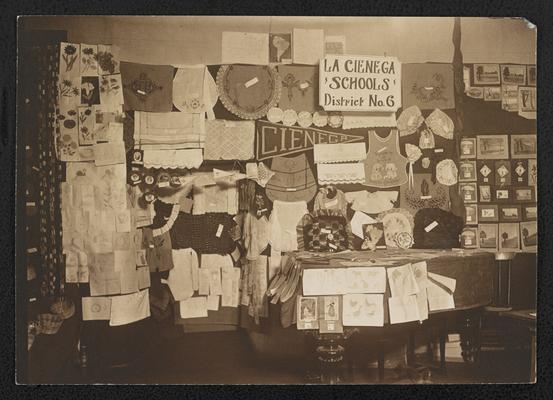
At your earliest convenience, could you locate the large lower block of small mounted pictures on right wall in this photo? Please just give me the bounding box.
[459,134,537,251]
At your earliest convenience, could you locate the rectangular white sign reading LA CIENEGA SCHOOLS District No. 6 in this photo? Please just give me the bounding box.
[319,55,401,112]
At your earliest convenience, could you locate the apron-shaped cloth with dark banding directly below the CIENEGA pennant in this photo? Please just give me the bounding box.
[266,154,317,202]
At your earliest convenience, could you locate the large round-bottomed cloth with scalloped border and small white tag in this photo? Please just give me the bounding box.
[216,65,282,119]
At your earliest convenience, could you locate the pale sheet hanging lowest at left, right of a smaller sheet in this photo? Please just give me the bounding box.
[109,289,150,326]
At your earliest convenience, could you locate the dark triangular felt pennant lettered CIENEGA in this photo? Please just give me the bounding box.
[255,120,366,161]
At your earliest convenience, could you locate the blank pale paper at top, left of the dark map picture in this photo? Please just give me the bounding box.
[221,32,269,65]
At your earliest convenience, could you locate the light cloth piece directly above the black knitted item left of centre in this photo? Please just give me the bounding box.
[192,172,238,215]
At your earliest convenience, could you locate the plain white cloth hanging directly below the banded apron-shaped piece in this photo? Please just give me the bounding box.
[269,200,309,251]
